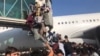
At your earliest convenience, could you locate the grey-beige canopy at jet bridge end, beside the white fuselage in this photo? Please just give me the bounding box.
[43,0,53,32]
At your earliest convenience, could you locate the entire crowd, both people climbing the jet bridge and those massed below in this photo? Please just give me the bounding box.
[0,0,100,56]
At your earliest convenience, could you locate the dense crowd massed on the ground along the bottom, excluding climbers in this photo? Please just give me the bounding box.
[2,35,100,56]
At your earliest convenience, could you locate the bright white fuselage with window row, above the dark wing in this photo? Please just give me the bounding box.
[52,13,100,38]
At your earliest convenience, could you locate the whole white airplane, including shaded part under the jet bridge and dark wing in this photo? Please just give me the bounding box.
[0,13,100,51]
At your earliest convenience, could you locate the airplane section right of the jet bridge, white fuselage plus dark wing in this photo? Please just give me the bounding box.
[52,13,100,43]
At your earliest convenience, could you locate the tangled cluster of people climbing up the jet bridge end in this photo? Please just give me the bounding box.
[25,2,52,40]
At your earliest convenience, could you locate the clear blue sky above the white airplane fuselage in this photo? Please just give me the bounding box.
[52,0,100,16]
